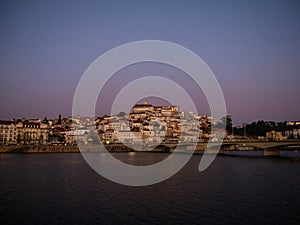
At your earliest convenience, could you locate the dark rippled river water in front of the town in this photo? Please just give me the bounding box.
[0,153,300,225]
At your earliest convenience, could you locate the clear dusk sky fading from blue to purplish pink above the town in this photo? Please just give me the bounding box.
[0,0,300,125]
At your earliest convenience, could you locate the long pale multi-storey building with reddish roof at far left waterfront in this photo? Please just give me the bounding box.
[0,119,49,145]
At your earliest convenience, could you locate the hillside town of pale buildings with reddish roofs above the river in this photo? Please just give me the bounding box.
[0,101,300,145]
